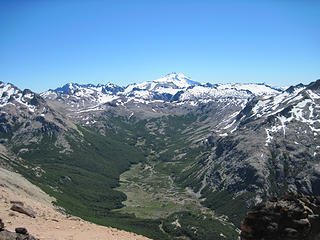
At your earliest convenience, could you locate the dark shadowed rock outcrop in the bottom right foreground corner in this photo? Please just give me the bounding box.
[240,194,320,240]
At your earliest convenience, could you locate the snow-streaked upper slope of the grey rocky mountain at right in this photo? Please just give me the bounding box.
[222,80,320,146]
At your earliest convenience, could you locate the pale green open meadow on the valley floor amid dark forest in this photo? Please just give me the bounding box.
[116,164,215,219]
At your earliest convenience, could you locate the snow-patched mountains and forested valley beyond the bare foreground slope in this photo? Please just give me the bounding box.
[0,73,320,239]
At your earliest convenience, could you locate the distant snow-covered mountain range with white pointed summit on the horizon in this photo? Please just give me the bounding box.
[41,73,283,116]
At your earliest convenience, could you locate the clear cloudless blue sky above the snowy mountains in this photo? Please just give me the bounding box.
[0,0,320,92]
